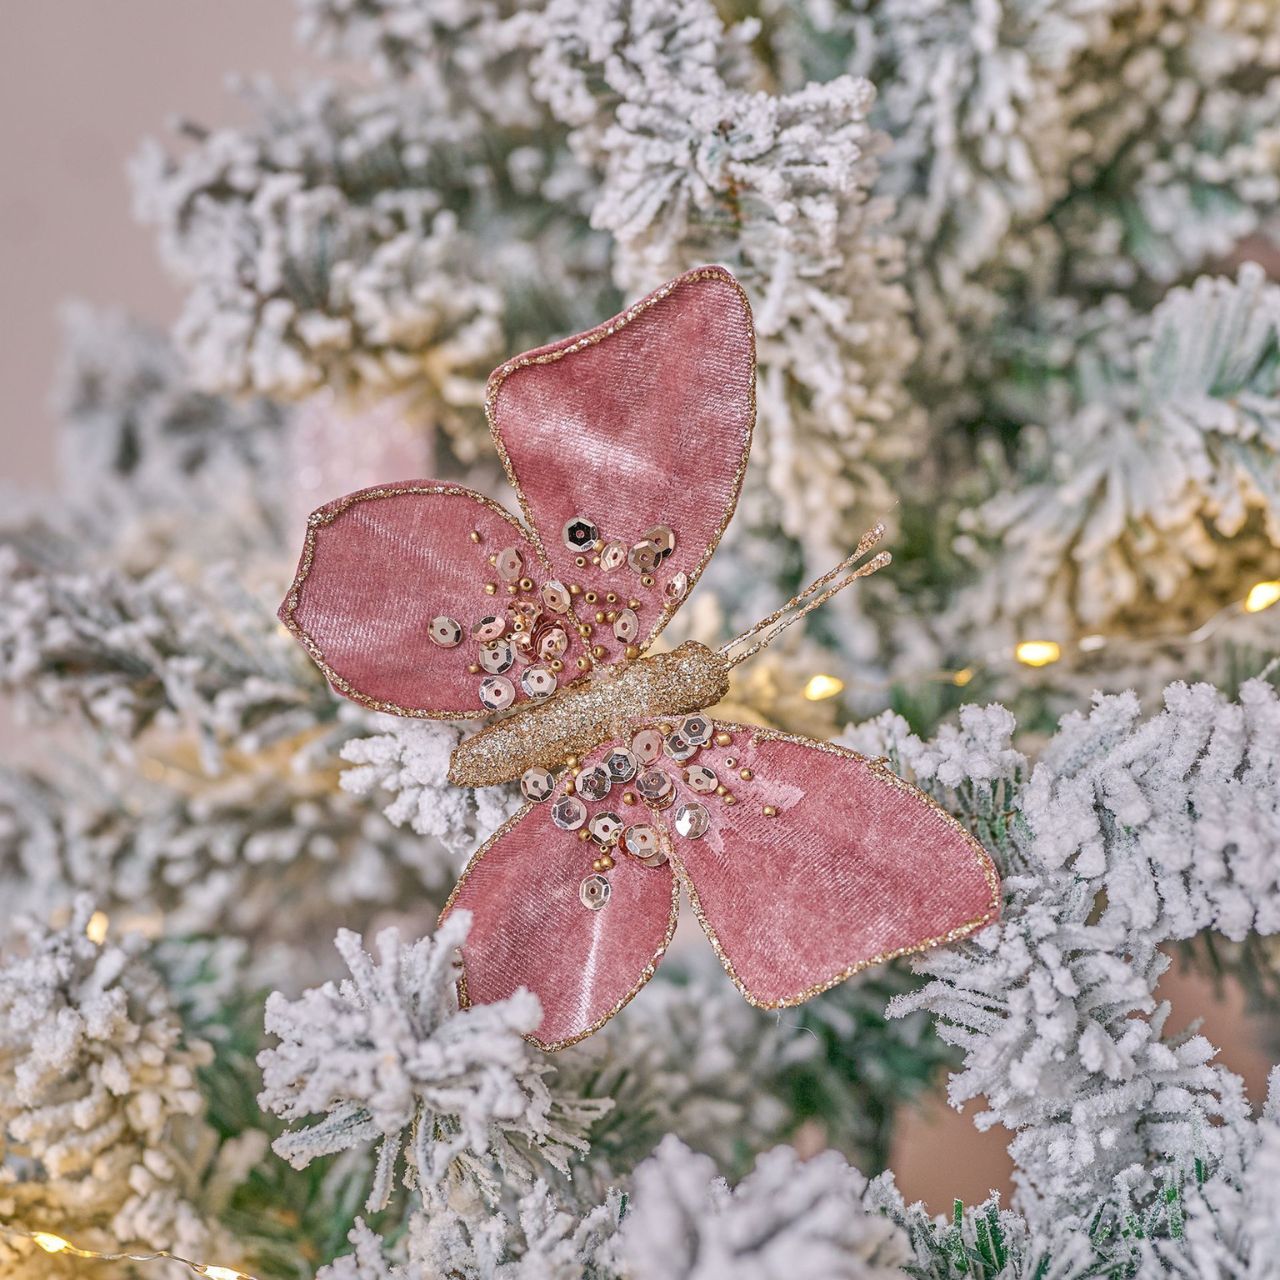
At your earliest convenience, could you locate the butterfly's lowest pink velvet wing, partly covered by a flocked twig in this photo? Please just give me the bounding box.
[445,803,673,1047]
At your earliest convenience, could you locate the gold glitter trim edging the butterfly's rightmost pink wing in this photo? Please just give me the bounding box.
[671,721,1000,1009]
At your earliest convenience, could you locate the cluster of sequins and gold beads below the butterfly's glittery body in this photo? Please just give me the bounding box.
[520,714,776,911]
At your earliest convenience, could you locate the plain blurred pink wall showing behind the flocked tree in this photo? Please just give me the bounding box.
[0,0,1267,1212]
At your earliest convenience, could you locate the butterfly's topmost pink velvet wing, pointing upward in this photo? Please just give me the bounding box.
[486,259,755,658]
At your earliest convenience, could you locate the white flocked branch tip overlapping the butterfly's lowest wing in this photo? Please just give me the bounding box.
[259,911,611,1210]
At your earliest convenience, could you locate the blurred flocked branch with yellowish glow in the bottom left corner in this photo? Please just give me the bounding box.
[0,899,216,1277]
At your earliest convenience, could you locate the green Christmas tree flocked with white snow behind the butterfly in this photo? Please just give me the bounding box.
[0,0,1280,1280]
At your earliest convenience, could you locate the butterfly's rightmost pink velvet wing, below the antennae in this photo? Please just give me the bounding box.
[672,724,1000,1009]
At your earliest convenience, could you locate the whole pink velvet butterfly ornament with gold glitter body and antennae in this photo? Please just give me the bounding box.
[280,266,1000,1050]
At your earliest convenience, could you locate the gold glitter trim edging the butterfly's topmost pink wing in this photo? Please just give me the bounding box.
[484,266,756,653]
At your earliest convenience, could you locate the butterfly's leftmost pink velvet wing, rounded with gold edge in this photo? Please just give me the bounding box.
[280,480,580,719]
